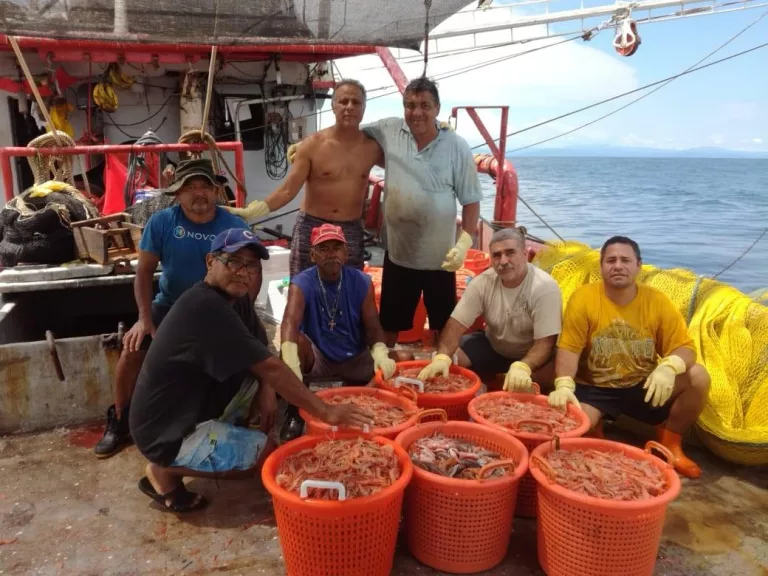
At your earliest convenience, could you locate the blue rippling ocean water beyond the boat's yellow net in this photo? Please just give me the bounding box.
[481,158,768,293]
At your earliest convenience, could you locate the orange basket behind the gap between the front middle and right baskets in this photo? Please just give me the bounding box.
[467,383,590,518]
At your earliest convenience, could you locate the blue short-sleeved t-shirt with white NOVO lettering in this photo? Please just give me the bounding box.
[139,204,250,306]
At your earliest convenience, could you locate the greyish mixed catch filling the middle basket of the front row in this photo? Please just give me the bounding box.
[408,434,514,480]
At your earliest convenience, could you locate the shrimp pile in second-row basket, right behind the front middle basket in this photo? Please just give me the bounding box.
[475,396,579,434]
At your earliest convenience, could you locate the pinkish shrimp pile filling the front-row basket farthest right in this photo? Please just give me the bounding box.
[545,450,668,501]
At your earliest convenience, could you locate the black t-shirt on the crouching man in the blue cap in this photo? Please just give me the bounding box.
[130,282,271,466]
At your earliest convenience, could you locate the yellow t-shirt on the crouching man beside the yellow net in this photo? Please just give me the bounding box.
[557,282,695,388]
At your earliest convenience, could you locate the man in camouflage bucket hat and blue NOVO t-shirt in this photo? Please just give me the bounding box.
[94,160,249,458]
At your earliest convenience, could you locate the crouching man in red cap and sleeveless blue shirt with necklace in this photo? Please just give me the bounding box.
[280,224,413,442]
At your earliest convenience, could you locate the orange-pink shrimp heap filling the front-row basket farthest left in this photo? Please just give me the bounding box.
[275,437,401,500]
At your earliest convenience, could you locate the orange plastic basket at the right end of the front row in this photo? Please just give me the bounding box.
[530,438,680,576]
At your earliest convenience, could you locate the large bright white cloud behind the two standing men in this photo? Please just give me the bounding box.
[322,5,639,147]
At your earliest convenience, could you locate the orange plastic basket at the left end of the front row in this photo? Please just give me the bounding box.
[261,433,413,576]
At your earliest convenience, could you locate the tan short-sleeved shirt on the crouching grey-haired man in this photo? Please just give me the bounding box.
[451,263,563,360]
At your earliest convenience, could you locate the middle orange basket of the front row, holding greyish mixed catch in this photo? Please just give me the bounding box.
[397,422,528,574]
